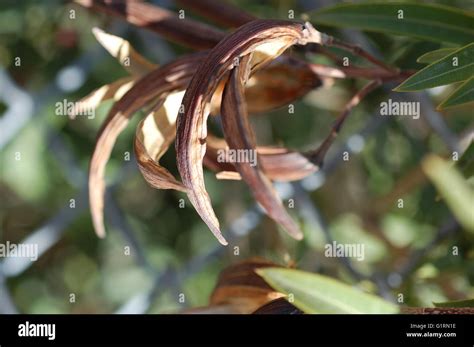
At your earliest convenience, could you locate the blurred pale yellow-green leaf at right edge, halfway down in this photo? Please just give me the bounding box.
[422,155,474,233]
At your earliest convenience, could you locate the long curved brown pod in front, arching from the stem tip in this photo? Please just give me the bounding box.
[176,20,325,245]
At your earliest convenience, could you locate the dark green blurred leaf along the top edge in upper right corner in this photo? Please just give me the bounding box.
[311,2,474,44]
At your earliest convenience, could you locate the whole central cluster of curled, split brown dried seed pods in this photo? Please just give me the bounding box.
[83,20,321,244]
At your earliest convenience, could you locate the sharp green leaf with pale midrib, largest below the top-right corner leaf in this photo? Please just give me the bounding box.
[394,43,474,92]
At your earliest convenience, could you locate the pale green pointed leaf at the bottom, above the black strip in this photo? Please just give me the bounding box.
[256,268,399,313]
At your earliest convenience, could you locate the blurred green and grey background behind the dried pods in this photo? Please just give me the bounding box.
[0,0,474,313]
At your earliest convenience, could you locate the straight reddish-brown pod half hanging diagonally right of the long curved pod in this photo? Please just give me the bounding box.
[222,54,303,240]
